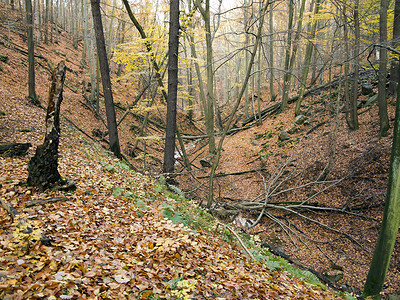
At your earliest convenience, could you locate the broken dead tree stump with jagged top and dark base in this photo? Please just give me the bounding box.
[27,61,66,189]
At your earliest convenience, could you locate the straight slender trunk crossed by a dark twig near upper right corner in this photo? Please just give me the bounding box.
[378,0,389,136]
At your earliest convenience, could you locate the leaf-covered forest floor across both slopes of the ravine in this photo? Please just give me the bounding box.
[0,1,400,299]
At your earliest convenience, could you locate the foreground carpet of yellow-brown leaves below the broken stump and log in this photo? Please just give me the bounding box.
[0,137,340,299]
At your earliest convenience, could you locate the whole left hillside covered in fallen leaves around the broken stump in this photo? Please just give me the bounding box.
[0,3,350,299]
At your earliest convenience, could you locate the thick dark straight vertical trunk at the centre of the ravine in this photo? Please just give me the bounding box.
[163,0,179,173]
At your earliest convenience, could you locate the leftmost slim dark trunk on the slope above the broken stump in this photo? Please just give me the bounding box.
[25,0,40,105]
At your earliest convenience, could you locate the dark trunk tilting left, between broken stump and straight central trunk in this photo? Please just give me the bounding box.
[90,0,122,158]
